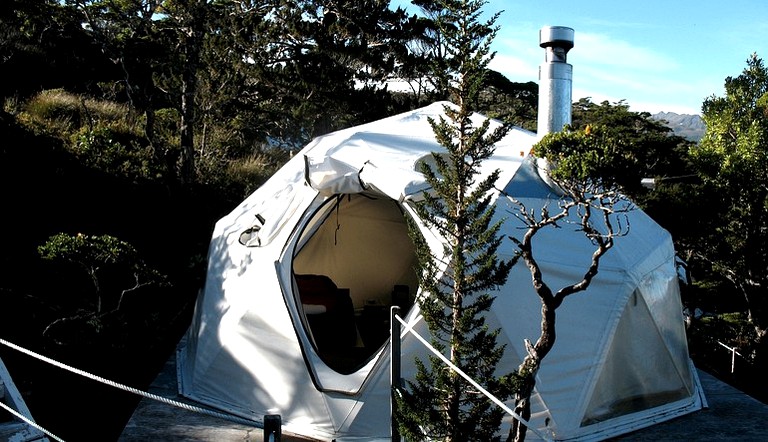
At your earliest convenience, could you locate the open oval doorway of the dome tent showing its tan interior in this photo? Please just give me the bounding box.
[293,194,418,374]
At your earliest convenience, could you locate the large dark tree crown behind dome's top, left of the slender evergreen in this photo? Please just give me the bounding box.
[203,0,424,148]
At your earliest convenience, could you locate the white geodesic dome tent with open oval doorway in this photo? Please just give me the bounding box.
[178,103,705,441]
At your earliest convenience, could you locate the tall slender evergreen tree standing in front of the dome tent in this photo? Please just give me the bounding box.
[395,0,512,441]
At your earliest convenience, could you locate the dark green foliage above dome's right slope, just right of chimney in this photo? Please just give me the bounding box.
[536,99,708,266]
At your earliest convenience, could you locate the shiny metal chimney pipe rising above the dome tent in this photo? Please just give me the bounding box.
[537,26,574,138]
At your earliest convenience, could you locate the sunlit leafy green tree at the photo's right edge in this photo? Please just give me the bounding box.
[690,54,768,340]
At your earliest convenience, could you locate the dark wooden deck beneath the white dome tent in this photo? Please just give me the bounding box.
[119,348,768,442]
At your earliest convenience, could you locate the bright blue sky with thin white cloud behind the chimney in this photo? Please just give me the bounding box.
[392,0,768,114]
